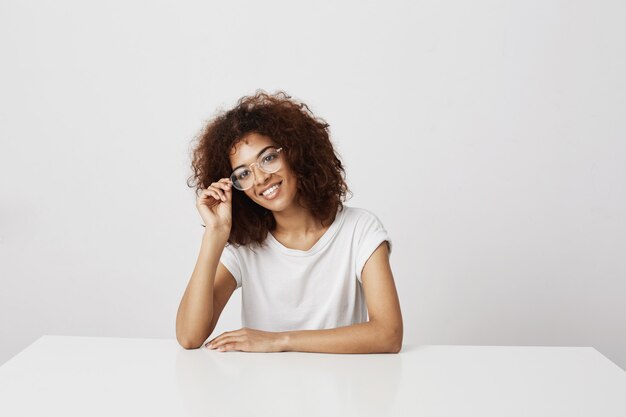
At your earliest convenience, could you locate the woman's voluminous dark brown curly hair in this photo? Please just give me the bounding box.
[187,90,352,245]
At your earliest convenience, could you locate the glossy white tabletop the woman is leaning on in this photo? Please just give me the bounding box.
[0,336,626,417]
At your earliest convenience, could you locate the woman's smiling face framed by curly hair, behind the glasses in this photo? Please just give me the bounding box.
[230,133,297,211]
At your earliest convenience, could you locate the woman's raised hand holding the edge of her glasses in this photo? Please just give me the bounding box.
[196,178,233,234]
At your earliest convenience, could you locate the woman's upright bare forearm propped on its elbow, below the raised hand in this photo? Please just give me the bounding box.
[176,230,228,349]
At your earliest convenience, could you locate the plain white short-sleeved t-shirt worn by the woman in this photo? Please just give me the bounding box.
[220,205,391,332]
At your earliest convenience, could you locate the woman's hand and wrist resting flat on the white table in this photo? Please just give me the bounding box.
[204,327,285,352]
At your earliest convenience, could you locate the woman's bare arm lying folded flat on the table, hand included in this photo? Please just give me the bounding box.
[202,241,403,353]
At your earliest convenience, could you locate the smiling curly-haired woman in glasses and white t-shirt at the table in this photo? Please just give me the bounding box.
[176,91,403,353]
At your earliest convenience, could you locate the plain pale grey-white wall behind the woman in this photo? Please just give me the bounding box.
[0,0,626,367]
